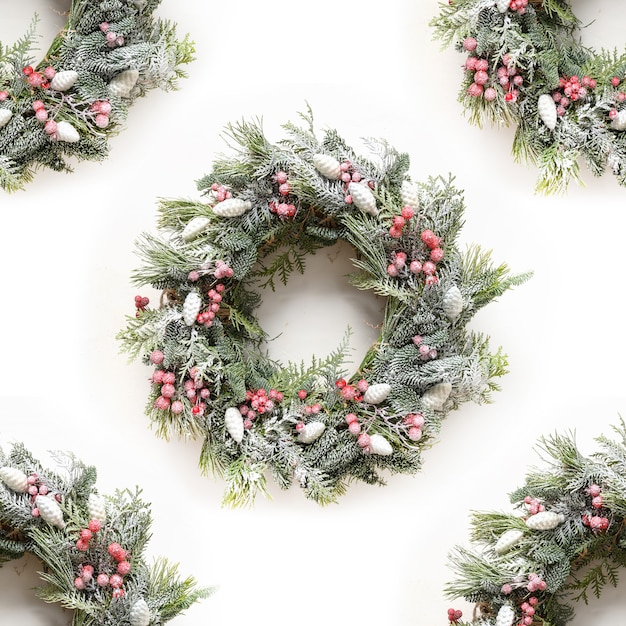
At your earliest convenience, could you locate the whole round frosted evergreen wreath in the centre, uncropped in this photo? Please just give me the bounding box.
[118,110,528,506]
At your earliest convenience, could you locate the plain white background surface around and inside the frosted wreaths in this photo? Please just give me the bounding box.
[0,0,626,626]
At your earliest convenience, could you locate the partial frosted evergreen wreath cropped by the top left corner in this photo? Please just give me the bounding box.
[0,0,193,191]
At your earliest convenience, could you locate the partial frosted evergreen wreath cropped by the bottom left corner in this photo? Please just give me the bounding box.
[0,444,210,626]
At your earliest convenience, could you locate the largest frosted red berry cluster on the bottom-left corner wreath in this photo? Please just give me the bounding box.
[74,519,131,598]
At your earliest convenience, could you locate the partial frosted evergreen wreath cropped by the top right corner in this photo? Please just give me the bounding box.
[431,0,626,193]
